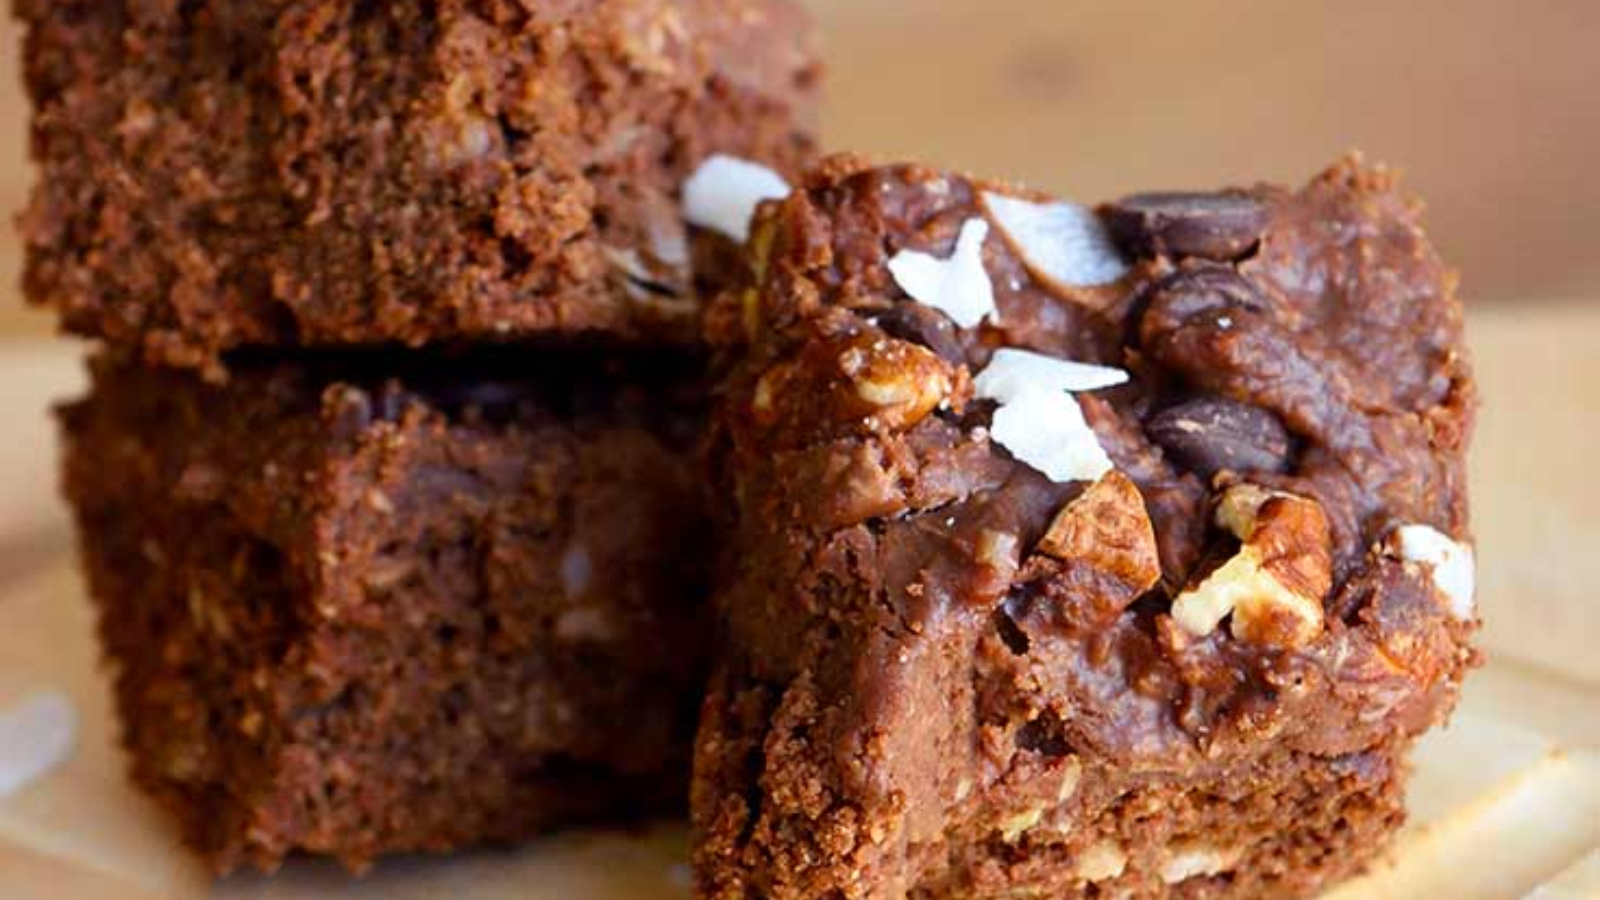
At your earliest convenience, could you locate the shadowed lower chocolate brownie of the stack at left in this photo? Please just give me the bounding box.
[61,354,707,871]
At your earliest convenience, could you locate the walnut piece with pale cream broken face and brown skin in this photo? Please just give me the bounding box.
[1173,485,1333,649]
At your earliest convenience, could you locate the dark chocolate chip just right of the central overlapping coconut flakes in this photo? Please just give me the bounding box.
[1146,397,1290,480]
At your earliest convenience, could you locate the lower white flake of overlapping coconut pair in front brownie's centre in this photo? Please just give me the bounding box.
[989,391,1112,484]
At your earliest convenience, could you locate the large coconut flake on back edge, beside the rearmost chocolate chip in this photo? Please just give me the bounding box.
[984,192,1128,287]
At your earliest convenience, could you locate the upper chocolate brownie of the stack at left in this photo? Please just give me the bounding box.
[14,0,818,370]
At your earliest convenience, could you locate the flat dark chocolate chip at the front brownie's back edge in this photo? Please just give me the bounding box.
[1107,191,1267,263]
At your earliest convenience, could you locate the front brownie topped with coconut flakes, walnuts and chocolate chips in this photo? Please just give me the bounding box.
[691,159,1477,900]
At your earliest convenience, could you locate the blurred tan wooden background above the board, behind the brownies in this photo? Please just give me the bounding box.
[0,0,1600,335]
